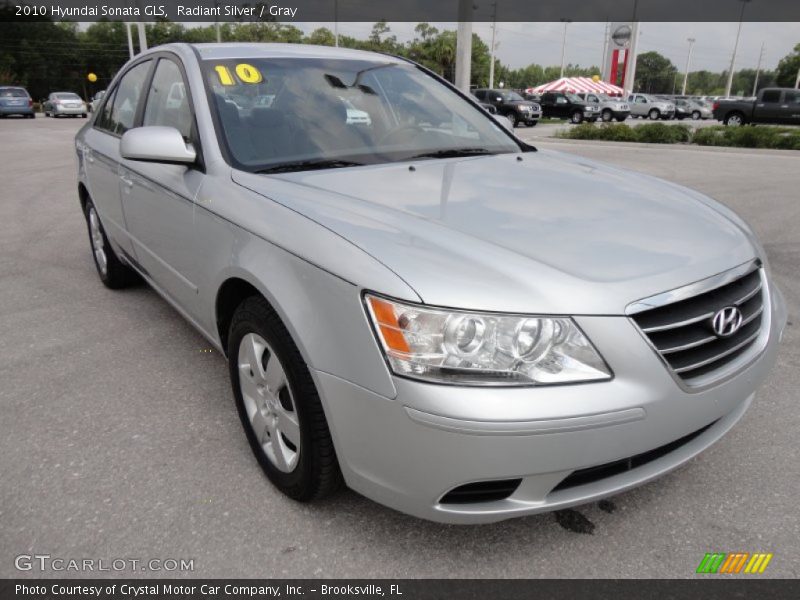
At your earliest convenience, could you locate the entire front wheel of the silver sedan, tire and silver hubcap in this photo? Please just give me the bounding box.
[228,296,342,502]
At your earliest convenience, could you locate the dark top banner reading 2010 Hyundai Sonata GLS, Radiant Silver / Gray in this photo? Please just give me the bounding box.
[0,0,800,22]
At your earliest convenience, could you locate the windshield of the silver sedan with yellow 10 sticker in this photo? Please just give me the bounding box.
[203,58,520,172]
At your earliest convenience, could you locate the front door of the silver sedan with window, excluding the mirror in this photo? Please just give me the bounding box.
[120,55,205,314]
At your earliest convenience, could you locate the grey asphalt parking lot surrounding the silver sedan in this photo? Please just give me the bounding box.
[0,118,800,578]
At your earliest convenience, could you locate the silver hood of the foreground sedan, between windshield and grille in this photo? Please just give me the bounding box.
[233,151,756,314]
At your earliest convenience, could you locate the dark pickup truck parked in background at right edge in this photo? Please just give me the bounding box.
[714,88,800,126]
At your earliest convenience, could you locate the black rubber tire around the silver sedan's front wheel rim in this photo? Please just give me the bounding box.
[228,296,343,502]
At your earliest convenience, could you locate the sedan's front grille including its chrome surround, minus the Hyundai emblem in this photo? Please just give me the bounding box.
[626,261,769,391]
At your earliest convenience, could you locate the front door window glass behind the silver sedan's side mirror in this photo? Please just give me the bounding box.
[142,58,193,138]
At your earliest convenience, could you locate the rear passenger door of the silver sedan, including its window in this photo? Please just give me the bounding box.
[82,60,153,262]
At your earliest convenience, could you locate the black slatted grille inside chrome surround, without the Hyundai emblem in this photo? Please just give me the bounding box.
[632,265,764,385]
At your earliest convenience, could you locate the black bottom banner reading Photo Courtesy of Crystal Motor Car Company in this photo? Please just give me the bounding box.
[0,576,800,600]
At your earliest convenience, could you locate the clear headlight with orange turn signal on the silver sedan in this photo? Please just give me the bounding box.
[365,294,611,385]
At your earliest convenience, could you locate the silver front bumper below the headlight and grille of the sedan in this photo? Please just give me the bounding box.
[315,288,786,523]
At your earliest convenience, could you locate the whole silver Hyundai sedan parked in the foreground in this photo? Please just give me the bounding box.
[76,44,786,523]
